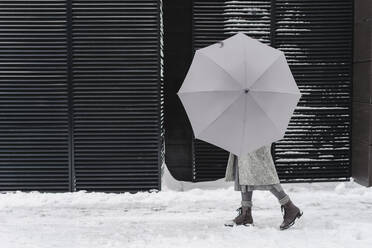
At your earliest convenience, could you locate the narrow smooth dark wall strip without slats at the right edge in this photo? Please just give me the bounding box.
[352,0,372,186]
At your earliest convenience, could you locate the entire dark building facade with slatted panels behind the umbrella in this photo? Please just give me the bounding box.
[0,0,372,192]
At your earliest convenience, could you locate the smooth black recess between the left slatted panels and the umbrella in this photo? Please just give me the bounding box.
[163,0,193,181]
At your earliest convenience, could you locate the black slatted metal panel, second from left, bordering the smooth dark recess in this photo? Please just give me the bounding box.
[72,0,163,191]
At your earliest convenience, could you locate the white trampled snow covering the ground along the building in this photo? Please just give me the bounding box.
[0,165,372,248]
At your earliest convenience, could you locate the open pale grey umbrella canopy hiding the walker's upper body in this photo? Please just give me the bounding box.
[177,33,301,156]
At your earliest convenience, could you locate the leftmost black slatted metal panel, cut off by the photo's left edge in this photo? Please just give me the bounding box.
[0,0,69,191]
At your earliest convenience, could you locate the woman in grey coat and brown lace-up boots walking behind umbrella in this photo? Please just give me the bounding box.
[225,144,302,230]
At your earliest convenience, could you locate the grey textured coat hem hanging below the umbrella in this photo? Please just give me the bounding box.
[225,144,280,186]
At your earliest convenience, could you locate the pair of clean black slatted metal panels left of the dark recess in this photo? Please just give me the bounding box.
[0,0,163,192]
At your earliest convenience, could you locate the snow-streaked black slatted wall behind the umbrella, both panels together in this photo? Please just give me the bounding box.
[193,0,353,182]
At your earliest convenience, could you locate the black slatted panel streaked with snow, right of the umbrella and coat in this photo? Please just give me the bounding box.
[274,0,353,181]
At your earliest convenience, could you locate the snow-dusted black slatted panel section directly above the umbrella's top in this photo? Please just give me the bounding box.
[192,0,271,49]
